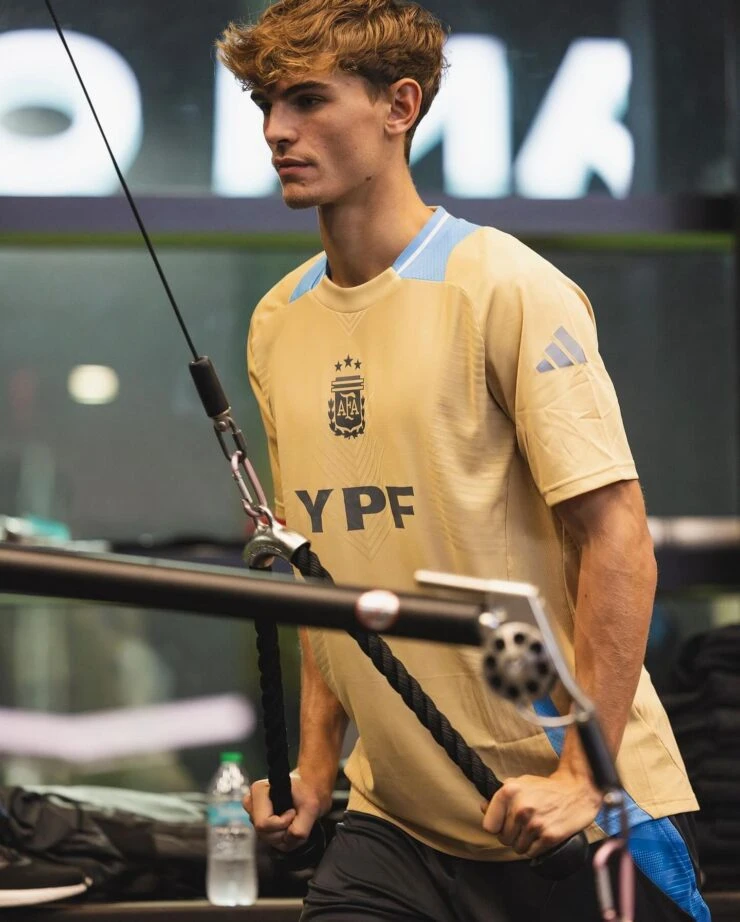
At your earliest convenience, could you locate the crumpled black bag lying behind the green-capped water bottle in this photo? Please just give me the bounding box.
[0,786,312,901]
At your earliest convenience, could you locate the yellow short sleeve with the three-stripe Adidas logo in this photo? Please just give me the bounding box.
[485,251,637,506]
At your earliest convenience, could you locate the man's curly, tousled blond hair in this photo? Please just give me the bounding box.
[216,0,447,159]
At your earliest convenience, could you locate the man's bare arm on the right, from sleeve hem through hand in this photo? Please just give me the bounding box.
[483,481,657,856]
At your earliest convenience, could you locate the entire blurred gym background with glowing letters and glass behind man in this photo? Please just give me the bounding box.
[0,0,740,791]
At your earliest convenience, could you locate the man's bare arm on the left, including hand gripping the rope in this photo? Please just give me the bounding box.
[244,629,347,851]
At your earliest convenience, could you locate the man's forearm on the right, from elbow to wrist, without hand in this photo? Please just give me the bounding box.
[561,531,656,774]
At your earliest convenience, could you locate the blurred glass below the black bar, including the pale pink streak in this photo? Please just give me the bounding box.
[0,596,299,792]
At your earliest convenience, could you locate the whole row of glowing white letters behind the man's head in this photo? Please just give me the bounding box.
[0,30,635,198]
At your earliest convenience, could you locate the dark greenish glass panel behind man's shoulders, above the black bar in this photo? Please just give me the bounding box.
[0,248,739,541]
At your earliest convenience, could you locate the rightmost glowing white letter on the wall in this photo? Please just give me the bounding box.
[515,39,635,198]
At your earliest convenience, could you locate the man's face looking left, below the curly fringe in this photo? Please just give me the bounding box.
[252,71,389,208]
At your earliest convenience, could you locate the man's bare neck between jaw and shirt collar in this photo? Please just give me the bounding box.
[318,171,432,288]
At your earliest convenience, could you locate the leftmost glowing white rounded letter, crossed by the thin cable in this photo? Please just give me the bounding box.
[0,29,143,195]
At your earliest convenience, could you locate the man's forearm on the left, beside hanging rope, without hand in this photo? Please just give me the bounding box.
[297,629,348,809]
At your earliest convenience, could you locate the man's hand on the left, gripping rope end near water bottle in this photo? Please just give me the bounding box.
[243,771,331,852]
